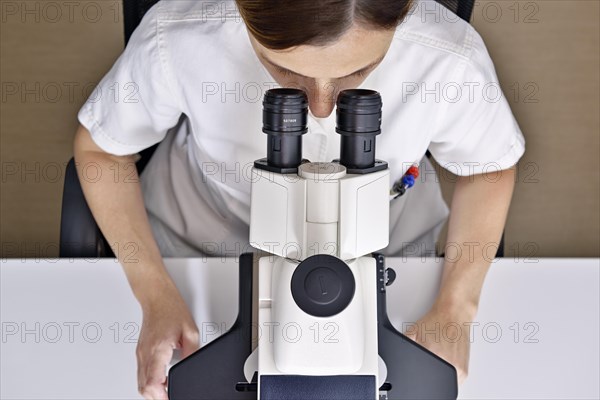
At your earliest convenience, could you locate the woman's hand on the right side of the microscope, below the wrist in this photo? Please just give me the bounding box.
[404,305,473,385]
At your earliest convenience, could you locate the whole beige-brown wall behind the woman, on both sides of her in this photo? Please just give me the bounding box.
[0,0,600,257]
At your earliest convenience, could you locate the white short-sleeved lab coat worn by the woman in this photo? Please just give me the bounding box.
[78,1,525,257]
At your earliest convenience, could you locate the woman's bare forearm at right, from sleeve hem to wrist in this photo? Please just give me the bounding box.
[437,168,515,318]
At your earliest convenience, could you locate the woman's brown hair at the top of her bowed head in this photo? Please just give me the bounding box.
[236,0,412,50]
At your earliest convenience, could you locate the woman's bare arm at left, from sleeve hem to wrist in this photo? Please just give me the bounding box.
[74,125,173,307]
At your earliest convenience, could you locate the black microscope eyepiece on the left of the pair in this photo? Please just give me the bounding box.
[263,88,308,168]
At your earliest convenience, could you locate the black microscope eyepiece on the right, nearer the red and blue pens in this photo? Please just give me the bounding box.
[335,89,383,170]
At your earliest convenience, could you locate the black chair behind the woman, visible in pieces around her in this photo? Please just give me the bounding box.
[59,0,482,258]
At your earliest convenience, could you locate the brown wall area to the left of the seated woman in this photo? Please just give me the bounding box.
[0,0,123,257]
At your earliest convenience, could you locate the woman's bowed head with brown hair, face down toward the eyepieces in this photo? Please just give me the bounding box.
[236,0,411,117]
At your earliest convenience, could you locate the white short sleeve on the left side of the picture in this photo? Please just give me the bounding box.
[78,4,181,155]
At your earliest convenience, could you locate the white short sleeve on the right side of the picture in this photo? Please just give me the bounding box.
[429,28,525,176]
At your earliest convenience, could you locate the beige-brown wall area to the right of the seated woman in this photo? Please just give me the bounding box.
[474,0,600,257]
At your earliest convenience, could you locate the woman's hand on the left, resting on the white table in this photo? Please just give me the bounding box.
[136,284,200,399]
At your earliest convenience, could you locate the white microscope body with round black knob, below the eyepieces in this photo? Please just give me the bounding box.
[250,89,390,399]
